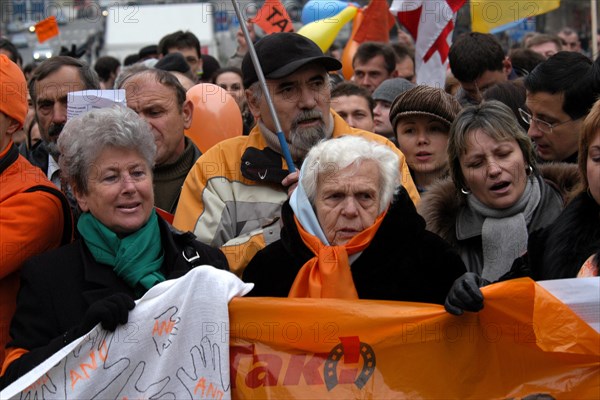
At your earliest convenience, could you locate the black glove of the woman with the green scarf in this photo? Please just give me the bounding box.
[65,293,135,342]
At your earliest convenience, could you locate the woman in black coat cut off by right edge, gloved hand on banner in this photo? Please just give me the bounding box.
[445,101,600,315]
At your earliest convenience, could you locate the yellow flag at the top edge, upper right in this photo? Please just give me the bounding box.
[470,0,560,33]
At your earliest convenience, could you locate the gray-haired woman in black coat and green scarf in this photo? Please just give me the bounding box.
[0,108,228,388]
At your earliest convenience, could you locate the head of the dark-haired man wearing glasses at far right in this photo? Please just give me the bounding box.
[519,51,600,163]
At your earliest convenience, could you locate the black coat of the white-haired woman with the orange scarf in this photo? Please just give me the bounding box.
[243,189,465,304]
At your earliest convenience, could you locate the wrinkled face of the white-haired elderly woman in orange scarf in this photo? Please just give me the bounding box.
[314,161,380,246]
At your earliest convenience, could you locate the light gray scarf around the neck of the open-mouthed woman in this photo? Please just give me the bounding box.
[467,177,541,282]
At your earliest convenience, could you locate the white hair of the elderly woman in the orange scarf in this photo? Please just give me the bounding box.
[301,135,400,213]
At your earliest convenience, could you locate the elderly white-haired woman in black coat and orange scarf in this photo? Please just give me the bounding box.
[243,136,465,304]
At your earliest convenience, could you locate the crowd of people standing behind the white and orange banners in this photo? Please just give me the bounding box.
[0,19,600,389]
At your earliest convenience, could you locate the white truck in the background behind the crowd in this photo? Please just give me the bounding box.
[102,0,217,62]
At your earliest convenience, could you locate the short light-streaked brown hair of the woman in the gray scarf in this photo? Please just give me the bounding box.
[448,100,537,190]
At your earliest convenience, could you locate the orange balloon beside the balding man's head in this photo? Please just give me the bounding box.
[185,83,243,153]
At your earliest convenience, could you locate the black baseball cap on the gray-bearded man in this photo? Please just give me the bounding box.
[242,32,342,88]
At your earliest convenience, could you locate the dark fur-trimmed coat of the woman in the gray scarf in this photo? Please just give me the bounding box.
[419,163,579,274]
